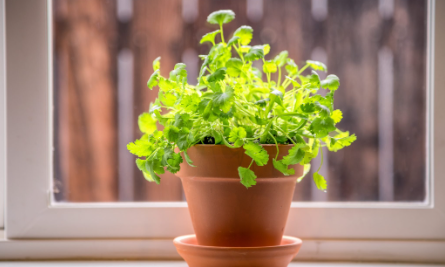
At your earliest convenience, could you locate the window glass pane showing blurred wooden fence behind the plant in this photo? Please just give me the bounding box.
[53,0,427,202]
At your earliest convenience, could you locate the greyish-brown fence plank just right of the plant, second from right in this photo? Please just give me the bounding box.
[326,0,380,201]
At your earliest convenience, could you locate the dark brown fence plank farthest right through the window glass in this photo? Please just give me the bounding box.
[388,0,427,201]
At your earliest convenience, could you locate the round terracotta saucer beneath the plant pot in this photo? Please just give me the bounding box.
[173,235,302,267]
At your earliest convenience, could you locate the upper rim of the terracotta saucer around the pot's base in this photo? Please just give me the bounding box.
[173,235,303,251]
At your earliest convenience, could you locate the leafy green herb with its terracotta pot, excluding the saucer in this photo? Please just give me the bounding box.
[127,10,356,247]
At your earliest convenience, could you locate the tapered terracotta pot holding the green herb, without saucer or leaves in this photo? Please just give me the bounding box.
[176,145,303,247]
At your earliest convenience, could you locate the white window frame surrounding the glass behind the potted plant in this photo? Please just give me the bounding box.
[0,0,445,261]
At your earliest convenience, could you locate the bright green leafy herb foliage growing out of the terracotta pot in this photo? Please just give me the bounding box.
[127,10,356,190]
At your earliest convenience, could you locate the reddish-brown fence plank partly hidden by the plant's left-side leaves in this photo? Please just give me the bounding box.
[130,0,183,201]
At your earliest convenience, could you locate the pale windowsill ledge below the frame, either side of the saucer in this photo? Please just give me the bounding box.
[0,230,445,267]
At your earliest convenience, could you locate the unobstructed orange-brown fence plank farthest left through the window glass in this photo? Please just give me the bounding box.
[54,0,117,201]
